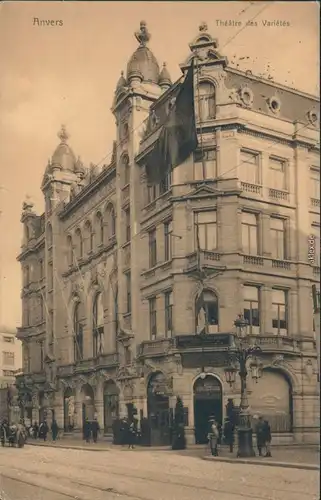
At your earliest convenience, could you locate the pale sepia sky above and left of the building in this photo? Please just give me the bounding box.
[0,1,319,327]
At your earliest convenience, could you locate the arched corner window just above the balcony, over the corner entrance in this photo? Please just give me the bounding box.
[195,290,219,333]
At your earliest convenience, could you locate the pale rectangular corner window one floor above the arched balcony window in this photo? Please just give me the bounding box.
[195,210,217,251]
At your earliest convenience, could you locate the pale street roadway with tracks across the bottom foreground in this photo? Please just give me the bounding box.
[0,446,319,500]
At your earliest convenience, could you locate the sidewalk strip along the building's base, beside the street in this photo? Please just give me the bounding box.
[26,438,320,470]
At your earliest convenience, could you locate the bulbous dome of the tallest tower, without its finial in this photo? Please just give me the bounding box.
[127,46,159,83]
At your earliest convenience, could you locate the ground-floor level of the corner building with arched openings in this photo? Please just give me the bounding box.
[16,340,320,445]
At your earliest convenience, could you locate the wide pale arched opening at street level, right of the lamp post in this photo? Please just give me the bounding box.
[249,368,293,434]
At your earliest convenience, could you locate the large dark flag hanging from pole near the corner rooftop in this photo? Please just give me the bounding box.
[146,59,198,184]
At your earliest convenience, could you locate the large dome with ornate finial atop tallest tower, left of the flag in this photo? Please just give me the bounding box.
[127,21,159,83]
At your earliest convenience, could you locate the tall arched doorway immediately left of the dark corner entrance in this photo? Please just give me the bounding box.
[147,372,170,446]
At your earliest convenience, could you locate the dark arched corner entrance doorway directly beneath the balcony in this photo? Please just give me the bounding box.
[193,375,223,444]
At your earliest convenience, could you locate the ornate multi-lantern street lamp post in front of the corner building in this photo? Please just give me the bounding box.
[225,315,262,457]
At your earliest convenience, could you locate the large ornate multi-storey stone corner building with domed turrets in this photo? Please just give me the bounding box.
[17,23,320,443]
